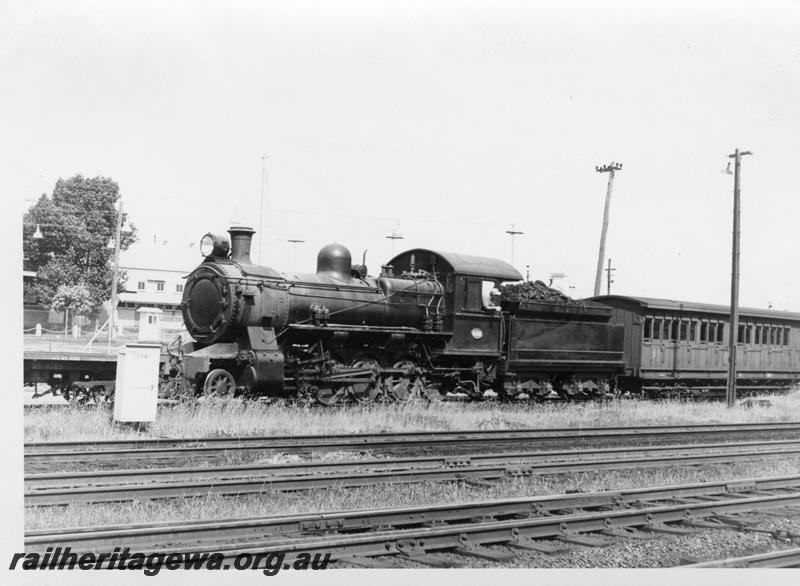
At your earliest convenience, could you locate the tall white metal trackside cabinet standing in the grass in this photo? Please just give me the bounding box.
[114,343,161,422]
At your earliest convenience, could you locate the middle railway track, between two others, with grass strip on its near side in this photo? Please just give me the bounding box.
[25,440,800,506]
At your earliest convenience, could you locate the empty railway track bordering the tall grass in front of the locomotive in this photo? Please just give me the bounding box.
[24,422,800,471]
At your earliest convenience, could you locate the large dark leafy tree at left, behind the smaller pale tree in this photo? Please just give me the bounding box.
[22,175,136,311]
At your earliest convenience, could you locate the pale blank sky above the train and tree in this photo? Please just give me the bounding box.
[0,0,800,311]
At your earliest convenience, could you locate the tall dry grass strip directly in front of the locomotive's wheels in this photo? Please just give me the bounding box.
[25,391,800,442]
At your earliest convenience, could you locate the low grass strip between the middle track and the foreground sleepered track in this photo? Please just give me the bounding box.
[25,457,800,530]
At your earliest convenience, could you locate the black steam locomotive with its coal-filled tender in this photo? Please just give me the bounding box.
[182,227,625,404]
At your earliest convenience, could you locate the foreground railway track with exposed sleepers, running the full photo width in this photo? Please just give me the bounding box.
[25,475,800,567]
